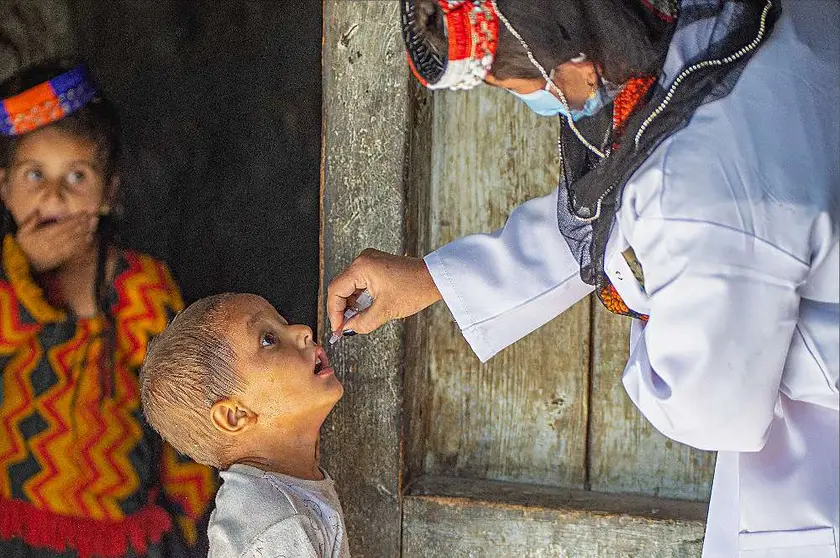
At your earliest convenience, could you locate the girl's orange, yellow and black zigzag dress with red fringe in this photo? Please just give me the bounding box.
[0,236,215,558]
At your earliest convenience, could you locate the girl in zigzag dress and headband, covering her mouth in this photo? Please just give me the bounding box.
[0,61,214,558]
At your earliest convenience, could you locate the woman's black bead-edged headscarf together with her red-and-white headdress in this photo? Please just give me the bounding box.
[401,0,779,324]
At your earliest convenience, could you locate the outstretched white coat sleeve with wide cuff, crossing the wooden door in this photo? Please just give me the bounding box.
[425,190,592,362]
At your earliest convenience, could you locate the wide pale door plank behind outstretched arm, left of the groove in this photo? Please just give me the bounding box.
[408,88,589,486]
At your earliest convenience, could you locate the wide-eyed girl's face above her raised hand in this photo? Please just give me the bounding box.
[0,126,109,226]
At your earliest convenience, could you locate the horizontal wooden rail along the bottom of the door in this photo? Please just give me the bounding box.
[403,478,706,558]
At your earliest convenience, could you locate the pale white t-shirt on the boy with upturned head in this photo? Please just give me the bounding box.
[207,464,350,558]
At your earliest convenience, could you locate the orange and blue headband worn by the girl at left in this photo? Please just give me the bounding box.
[0,66,98,136]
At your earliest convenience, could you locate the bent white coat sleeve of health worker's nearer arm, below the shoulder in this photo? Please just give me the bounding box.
[623,206,808,451]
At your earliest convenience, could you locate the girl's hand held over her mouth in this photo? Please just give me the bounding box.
[16,210,98,273]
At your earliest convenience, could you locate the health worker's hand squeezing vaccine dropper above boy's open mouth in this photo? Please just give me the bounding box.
[327,248,441,333]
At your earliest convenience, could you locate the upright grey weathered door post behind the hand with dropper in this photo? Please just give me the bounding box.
[322,0,409,558]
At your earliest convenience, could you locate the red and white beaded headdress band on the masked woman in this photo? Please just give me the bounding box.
[400,0,499,89]
